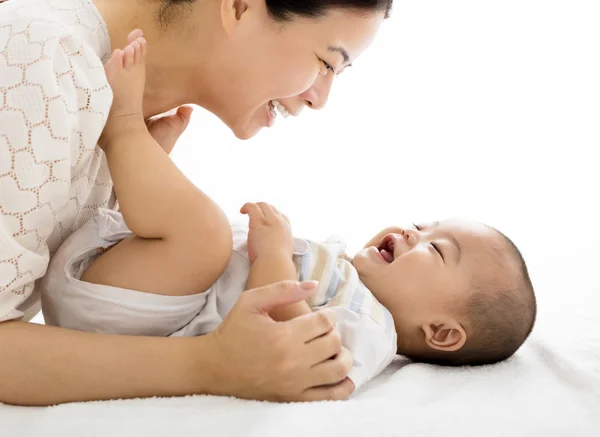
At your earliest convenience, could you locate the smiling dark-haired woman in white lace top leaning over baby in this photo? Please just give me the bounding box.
[0,0,391,405]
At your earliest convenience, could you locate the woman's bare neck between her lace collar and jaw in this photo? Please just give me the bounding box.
[94,0,220,118]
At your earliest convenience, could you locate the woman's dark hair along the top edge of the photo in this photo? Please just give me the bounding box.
[159,0,394,24]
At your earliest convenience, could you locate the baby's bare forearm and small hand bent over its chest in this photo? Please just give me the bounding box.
[240,203,311,321]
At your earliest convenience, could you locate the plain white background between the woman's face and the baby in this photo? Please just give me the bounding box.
[173,0,600,330]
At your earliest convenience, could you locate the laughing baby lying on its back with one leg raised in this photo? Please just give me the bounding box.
[40,33,536,388]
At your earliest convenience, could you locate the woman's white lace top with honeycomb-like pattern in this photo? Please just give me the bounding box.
[0,0,114,321]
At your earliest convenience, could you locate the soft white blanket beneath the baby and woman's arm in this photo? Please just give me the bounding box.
[0,324,600,437]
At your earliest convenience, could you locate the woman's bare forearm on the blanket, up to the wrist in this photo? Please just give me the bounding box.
[0,322,215,405]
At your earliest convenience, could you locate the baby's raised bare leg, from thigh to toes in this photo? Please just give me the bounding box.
[82,32,231,295]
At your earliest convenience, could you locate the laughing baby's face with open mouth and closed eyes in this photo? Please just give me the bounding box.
[353,220,498,333]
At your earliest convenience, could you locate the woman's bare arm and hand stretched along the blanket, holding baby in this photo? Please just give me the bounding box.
[0,282,352,405]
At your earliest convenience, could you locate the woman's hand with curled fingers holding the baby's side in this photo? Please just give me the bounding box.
[207,281,354,401]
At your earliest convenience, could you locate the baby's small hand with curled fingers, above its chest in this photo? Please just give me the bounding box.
[240,202,294,262]
